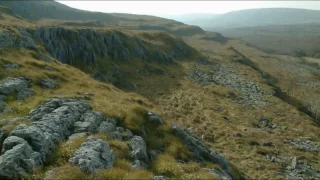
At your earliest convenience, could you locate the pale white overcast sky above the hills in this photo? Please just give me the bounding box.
[59,1,320,15]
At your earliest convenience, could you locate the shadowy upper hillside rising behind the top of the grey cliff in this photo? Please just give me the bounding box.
[0,0,204,36]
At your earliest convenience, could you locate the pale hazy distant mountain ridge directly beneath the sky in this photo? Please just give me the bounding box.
[160,8,320,30]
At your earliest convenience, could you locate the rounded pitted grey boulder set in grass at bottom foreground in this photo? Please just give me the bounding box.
[69,137,115,173]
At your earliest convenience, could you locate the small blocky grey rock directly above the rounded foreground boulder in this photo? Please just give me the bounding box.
[74,111,103,133]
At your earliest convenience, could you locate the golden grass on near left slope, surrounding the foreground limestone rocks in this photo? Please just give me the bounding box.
[0,14,219,179]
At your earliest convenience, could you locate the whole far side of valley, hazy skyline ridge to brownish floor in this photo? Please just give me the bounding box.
[172,8,320,57]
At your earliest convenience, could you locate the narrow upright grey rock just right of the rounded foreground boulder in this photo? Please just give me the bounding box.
[129,136,149,169]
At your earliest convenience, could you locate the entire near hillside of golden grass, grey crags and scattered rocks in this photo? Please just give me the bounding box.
[0,2,320,180]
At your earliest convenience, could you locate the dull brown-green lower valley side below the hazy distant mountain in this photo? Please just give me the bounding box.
[216,24,320,58]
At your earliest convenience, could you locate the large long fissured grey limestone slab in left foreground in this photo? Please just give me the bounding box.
[10,99,90,161]
